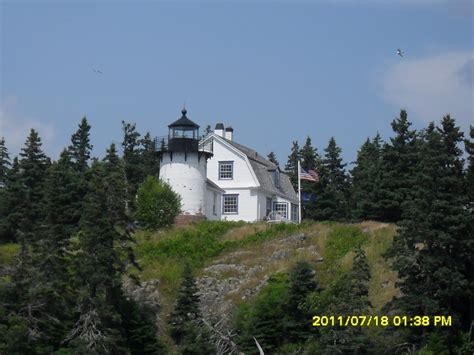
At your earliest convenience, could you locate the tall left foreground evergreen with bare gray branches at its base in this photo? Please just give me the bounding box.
[66,161,129,353]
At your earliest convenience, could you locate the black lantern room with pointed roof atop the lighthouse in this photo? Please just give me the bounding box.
[168,108,199,152]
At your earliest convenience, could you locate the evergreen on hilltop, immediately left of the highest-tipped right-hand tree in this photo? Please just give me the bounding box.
[350,133,382,220]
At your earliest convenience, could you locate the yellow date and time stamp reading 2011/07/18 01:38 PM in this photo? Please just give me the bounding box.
[312,315,453,328]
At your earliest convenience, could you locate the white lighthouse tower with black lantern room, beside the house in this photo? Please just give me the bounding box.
[160,108,212,223]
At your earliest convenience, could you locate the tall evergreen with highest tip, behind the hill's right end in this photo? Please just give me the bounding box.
[379,110,419,222]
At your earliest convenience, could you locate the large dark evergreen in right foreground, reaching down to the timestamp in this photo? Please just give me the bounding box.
[387,115,474,351]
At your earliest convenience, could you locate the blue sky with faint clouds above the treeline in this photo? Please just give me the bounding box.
[0,0,474,167]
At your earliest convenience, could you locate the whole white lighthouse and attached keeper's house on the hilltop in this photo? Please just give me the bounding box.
[157,109,298,223]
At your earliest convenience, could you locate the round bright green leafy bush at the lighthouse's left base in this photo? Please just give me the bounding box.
[135,176,181,229]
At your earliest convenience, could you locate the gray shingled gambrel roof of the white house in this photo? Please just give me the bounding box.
[224,138,298,203]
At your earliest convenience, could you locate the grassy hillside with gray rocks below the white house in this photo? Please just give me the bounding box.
[131,222,399,342]
